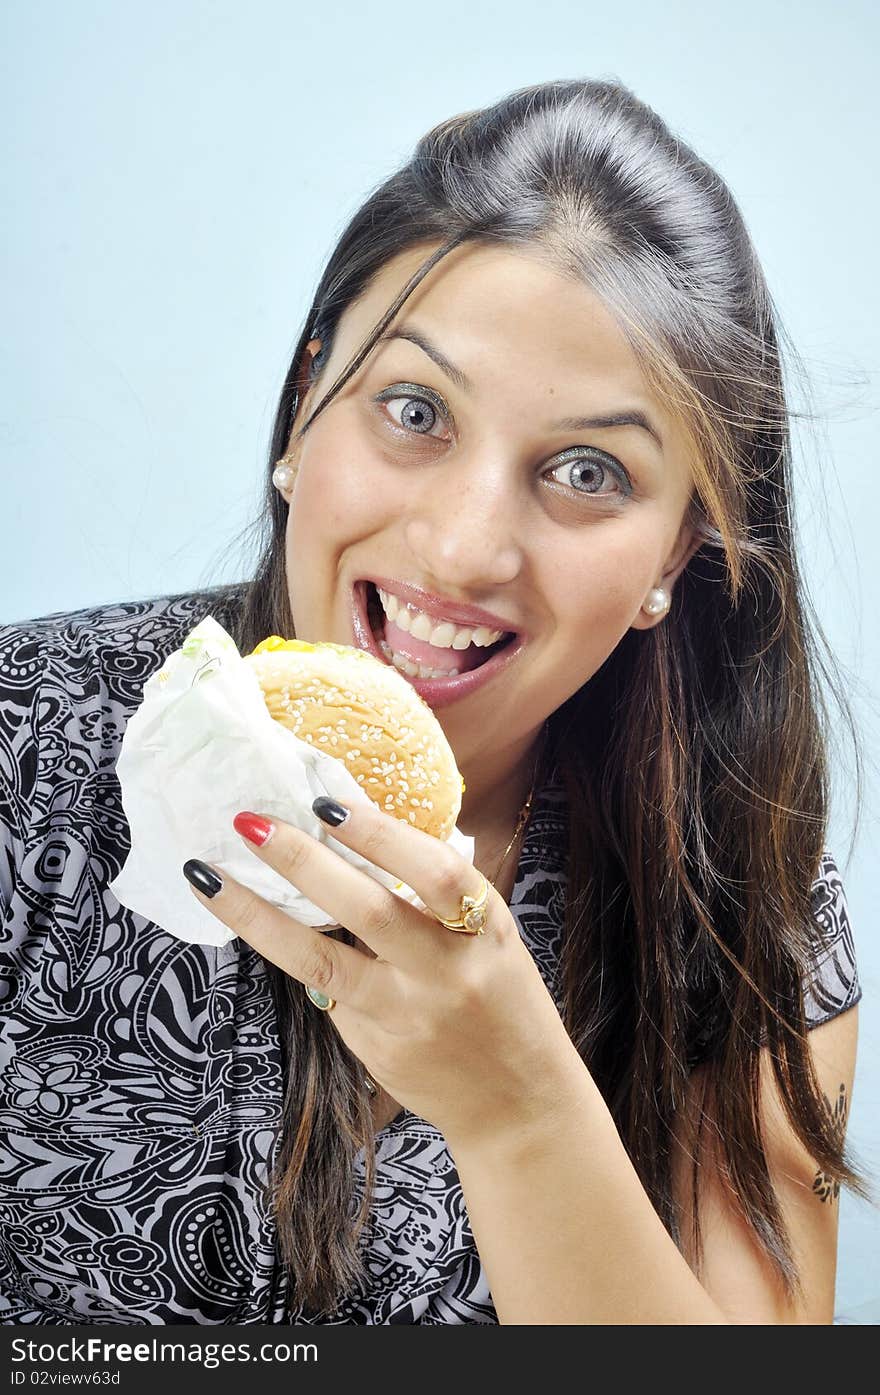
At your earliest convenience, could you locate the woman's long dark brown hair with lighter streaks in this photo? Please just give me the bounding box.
[184,80,869,1311]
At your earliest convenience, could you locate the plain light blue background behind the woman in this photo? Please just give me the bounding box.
[0,0,880,1321]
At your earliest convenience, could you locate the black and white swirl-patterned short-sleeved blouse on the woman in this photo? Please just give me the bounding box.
[0,585,860,1324]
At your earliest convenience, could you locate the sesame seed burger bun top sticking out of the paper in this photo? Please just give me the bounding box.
[244,635,464,838]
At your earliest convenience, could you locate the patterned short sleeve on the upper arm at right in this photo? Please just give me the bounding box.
[805,852,862,1028]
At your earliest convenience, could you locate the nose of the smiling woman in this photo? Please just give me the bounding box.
[406,460,524,597]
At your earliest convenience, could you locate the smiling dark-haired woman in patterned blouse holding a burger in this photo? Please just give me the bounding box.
[0,81,866,1324]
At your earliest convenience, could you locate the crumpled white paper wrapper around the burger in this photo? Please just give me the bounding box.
[110,615,474,944]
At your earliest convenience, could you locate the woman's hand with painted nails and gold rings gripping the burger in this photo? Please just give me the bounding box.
[185,801,584,1145]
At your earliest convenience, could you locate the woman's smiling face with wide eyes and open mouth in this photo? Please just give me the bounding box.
[287,244,699,771]
